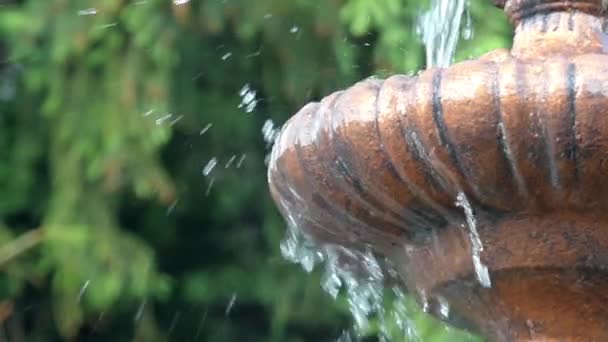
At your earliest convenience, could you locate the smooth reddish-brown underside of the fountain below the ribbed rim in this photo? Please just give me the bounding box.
[392,212,608,341]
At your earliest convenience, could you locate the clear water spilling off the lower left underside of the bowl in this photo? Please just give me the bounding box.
[281,224,418,341]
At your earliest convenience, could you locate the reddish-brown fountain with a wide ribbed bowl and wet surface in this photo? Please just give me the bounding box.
[269,0,608,341]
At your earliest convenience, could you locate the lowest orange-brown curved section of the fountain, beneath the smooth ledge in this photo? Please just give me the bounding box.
[443,269,608,342]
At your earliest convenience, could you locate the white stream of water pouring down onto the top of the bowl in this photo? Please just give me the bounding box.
[417,0,473,68]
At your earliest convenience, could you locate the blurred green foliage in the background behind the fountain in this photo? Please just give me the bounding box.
[0,0,511,341]
